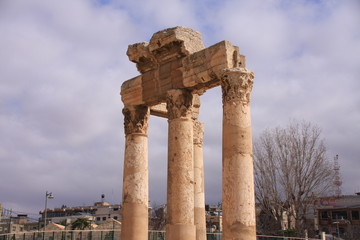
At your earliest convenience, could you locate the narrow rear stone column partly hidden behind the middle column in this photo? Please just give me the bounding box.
[194,120,206,240]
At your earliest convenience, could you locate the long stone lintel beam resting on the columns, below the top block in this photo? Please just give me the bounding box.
[121,41,245,106]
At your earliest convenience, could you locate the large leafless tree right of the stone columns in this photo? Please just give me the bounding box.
[254,121,333,236]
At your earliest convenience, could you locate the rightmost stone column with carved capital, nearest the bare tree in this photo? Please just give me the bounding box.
[221,68,256,240]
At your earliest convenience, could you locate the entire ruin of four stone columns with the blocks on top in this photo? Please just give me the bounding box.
[121,27,256,240]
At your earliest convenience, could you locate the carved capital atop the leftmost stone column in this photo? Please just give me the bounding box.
[123,105,150,135]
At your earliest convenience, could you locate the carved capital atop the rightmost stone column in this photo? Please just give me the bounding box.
[221,68,254,104]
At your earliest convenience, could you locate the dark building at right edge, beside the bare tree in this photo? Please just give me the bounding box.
[314,193,360,239]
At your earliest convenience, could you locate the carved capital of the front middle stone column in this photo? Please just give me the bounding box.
[166,89,193,120]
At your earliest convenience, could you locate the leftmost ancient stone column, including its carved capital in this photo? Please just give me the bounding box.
[121,106,149,240]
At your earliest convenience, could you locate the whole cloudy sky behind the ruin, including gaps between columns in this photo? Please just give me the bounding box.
[0,0,360,216]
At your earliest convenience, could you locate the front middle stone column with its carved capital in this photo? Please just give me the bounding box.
[166,89,196,240]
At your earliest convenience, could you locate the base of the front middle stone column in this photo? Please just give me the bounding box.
[166,224,196,240]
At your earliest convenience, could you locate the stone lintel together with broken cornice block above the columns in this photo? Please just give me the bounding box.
[121,27,245,106]
